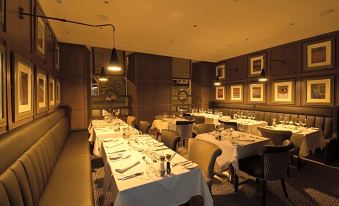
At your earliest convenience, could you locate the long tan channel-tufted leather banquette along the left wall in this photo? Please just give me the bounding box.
[0,107,94,206]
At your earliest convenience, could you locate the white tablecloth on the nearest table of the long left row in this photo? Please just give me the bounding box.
[103,136,213,206]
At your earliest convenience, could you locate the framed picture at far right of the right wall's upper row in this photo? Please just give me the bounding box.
[303,38,335,71]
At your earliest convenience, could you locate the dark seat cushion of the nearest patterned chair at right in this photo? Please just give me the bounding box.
[239,155,264,178]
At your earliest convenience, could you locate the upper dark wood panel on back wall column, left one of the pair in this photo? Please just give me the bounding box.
[135,53,153,80]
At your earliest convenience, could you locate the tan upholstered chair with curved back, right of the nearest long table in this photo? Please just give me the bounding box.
[188,139,222,191]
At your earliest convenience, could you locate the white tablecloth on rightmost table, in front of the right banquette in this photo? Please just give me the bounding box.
[267,125,325,157]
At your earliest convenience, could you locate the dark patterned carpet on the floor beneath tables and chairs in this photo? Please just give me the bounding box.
[92,157,339,206]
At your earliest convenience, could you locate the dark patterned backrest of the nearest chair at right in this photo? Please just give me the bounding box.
[263,140,293,180]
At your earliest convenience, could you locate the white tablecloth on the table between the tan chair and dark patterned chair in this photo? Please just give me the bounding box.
[196,131,269,171]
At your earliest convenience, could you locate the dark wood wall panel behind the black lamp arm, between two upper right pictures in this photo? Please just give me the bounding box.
[268,43,301,76]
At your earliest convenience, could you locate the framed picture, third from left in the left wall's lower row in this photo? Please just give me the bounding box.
[35,68,47,114]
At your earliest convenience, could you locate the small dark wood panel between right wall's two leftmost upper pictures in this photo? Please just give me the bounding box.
[226,56,248,81]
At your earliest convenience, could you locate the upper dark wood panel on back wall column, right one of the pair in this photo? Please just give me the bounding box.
[153,56,171,80]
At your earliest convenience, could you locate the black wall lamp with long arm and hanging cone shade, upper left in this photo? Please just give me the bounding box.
[19,7,121,71]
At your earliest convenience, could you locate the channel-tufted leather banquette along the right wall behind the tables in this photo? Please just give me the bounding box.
[209,102,339,162]
